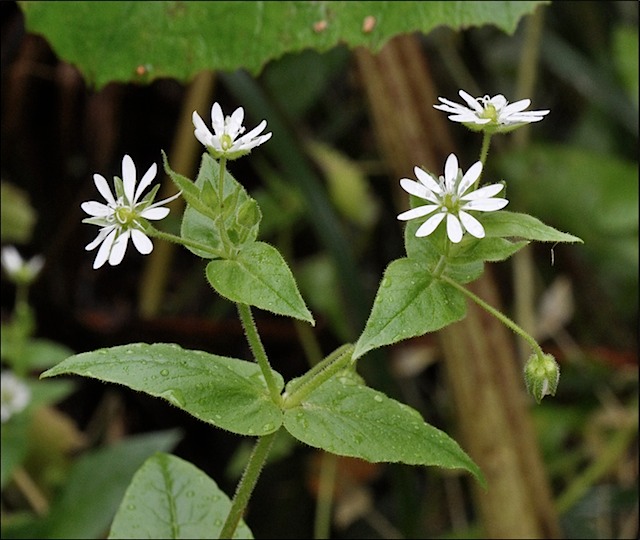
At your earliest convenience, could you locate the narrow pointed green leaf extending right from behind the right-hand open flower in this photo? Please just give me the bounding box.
[482,210,582,243]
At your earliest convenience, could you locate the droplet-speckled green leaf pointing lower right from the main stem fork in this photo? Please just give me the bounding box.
[284,376,484,483]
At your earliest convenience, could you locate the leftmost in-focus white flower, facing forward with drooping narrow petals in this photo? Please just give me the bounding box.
[81,155,180,269]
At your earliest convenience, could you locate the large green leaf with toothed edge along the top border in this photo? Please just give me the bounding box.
[19,1,547,88]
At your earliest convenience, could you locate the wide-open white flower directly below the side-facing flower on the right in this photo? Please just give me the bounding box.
[398,154,509,243]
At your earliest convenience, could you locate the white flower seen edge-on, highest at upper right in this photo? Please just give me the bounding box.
[433,90,549,133]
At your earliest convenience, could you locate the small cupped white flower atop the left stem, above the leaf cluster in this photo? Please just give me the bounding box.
[192,102,271,159]
